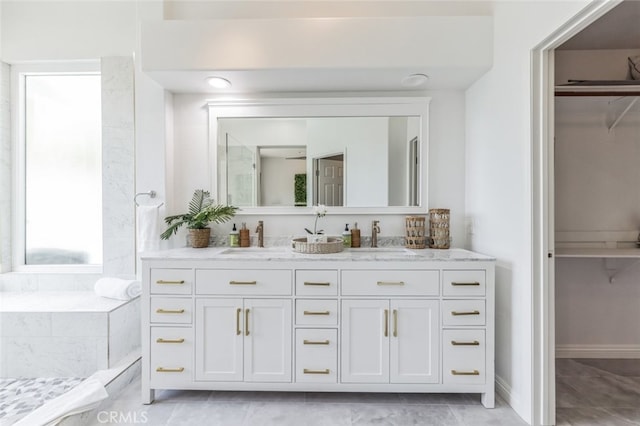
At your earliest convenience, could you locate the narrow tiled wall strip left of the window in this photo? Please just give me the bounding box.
[0,62,11,272]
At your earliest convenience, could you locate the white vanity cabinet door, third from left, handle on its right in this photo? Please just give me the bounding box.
[341,300,390,383]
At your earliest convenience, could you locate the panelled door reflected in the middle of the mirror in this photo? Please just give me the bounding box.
[313,154,345,206]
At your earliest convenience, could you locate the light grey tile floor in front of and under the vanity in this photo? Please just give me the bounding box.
[89,381,526,426]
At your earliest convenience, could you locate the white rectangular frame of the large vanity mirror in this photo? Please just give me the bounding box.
[207,97,431,215]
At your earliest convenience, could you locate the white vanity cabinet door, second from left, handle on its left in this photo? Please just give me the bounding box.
[244,299,292,382]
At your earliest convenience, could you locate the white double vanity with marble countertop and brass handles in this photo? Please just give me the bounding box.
[141,247,495,408]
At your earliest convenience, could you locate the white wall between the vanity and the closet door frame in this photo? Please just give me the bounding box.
[466,1,588,422]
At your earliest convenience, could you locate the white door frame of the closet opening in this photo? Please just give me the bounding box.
[531,0,623,425]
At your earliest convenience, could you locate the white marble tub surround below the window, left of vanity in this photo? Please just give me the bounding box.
[0,291,140,378]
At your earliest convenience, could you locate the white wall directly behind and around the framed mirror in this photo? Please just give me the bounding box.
[167,91,466,241]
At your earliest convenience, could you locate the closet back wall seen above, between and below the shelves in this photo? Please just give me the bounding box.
[555,50,640,358]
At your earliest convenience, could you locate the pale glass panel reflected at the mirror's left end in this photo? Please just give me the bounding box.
[226,133,259,207]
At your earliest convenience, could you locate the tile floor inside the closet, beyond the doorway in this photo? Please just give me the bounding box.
[556,359,640,426]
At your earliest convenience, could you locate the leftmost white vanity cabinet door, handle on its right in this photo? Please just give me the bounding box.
[196,299,244,381]
